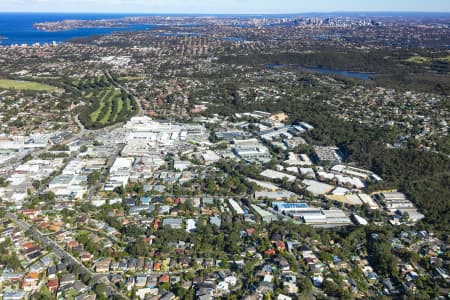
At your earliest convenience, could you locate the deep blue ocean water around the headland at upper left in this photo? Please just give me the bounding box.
[0,13,153,46]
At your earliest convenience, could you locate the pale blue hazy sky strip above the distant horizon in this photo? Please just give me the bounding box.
[0,0,450,14]
